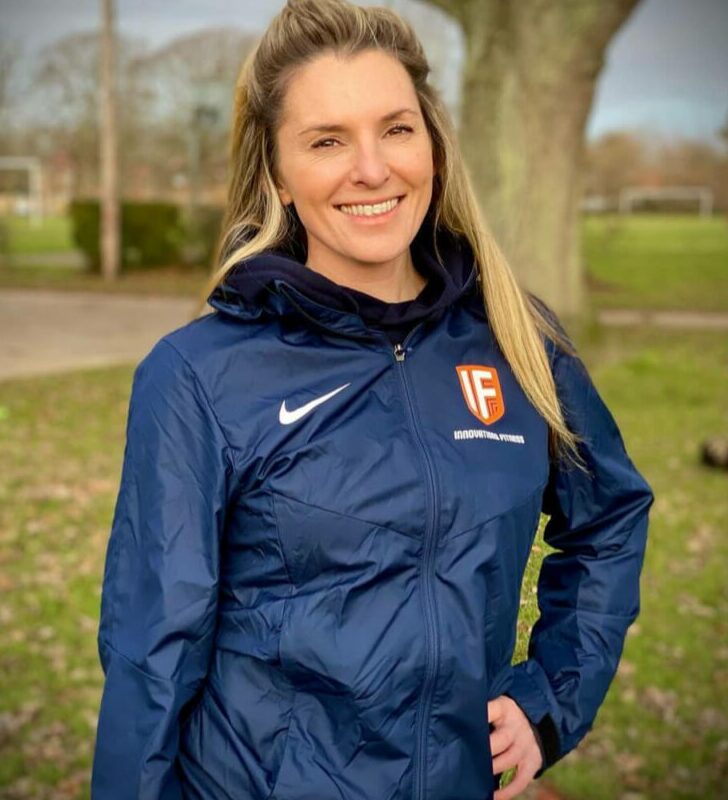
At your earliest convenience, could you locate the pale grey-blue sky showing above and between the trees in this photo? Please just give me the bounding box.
[0,0,728,141]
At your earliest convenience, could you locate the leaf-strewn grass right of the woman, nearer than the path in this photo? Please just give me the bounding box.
[548,330,728,800]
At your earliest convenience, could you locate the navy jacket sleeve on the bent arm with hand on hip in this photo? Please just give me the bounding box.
[506,336,653,777]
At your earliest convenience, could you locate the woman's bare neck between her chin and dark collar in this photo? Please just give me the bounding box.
[306,248,427,303]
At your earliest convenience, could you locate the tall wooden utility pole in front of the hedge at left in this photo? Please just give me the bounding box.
[100,0,121,281]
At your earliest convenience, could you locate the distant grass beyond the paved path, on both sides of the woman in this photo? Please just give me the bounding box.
[0,215,728,311]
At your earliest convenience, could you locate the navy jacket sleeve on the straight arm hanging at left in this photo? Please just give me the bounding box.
[91,340,233,800]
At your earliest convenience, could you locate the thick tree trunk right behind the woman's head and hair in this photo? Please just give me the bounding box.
[430,0,638,315]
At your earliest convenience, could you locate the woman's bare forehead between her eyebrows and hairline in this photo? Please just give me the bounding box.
[281,50,419,129]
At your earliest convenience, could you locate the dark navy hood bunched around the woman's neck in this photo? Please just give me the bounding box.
[208,215,482,335]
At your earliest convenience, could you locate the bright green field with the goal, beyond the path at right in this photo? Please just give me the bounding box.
[582,215,728,311]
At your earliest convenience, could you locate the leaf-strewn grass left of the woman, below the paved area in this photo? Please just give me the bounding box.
[0,368,131,800]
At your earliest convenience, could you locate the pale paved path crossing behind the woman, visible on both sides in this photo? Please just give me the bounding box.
[0,289,728,381]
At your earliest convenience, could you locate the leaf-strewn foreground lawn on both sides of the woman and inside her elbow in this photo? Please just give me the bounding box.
[0,329,728,800]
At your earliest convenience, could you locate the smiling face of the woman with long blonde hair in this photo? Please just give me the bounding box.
[276,50,434,285]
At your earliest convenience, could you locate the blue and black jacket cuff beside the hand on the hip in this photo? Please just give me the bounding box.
[504,659,562,778]
